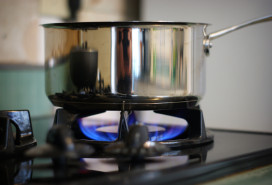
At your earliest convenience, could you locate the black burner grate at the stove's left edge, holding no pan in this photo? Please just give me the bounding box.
[0,110,37,157]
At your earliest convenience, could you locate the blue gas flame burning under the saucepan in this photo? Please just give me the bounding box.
[78,113,187,141]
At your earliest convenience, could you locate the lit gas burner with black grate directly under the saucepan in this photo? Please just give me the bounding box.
[54,106,213,149]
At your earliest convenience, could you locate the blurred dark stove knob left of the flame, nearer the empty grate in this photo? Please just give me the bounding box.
[25,125,94,159]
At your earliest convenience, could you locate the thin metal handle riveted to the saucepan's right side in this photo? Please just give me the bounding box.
[203,15,272,55]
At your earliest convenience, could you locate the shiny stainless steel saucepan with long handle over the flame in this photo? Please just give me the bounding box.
[43,15,272,111]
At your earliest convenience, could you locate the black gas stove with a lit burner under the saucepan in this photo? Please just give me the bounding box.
[0,106,272,185]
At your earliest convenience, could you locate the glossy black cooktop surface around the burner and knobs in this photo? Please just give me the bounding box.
[0,113,272,185]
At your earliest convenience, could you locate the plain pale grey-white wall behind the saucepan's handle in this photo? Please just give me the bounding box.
[141,0,272,132]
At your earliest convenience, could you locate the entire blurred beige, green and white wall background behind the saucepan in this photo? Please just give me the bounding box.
[0,0,272,132]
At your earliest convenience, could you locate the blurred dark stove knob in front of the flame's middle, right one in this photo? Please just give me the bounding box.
[105,124,169,159]
